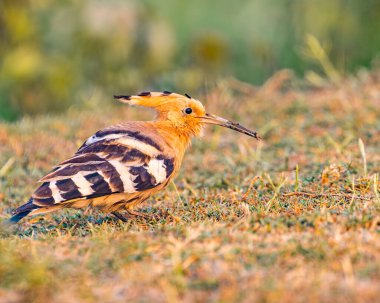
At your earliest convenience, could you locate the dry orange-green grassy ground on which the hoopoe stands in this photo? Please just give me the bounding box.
[0,72,380,302]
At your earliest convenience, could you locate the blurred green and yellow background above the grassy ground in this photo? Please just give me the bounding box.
[0,0,380,121]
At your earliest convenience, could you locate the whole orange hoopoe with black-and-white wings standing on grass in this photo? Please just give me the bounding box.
[9,91,259,223]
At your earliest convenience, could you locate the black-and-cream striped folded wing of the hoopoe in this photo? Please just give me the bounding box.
[32,129,174,206]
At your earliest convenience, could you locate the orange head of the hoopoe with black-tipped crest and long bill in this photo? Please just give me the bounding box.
[114,91,260,139]
